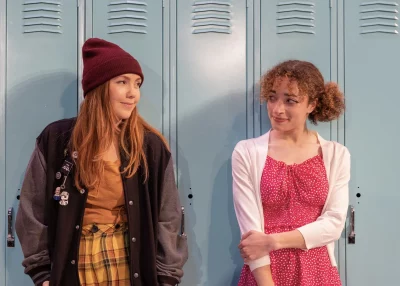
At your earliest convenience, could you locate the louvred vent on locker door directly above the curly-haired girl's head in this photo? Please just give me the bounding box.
[276,1,315,35]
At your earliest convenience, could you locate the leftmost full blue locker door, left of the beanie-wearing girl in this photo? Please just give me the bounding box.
[0,0,78,286]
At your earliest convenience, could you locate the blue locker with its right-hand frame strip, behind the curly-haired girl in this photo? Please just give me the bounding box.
[255,0,346,285]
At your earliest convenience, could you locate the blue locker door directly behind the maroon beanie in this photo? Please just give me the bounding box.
[88,0,163,130]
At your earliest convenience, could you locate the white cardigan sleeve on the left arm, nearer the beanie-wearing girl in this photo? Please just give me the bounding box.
[232,141,270,271]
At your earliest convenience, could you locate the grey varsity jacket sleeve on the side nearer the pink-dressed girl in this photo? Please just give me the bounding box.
[157,158,188,286]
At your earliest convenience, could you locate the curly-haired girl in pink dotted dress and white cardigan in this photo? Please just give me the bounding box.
[232,60,350,286]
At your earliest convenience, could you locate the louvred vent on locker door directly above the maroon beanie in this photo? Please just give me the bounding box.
[108,0,147,34]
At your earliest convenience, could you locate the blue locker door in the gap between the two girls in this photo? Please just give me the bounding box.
[177,0,249,286]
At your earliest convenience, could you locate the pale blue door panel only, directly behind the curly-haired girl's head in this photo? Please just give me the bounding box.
[261,0,335,139]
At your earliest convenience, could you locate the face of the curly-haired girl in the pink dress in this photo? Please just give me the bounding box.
[267,77,316,132]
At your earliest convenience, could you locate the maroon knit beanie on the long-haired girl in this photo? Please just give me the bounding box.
[82,38,144,96]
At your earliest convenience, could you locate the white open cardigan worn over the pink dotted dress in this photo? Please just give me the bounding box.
[232,132,350,271]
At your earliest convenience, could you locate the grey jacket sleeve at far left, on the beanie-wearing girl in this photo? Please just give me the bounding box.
[15,144,51,285]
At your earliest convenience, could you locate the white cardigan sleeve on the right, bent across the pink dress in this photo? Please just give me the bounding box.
[298,147,350,249]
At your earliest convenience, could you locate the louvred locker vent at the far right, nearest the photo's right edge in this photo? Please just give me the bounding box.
[360,1,399,34]
